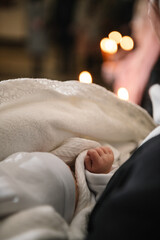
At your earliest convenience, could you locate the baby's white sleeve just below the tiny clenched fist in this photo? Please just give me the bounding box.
[85,164,118,200]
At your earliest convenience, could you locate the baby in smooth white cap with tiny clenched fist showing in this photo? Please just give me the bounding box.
[0,147,114,223]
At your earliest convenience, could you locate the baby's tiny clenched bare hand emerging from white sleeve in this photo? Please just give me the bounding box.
[84,146,114,173]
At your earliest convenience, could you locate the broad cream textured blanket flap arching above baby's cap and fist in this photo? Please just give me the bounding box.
[0,79,155,160]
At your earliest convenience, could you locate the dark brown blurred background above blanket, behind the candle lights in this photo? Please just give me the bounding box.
[0,0,159,114]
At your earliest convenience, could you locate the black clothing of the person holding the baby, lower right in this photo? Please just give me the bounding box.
[86,135,160,240]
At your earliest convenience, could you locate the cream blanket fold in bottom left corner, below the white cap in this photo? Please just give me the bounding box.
[0,206,68,240]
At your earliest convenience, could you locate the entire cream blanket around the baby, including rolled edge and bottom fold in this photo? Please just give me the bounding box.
[0,79,156,240]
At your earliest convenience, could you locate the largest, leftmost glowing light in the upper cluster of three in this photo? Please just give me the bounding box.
[100,38,118,54]
